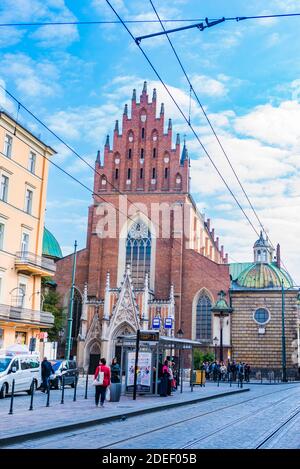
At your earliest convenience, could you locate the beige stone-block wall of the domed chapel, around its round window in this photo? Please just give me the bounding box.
[231,289,298,370]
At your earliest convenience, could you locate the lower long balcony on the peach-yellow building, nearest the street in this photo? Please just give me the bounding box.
[0,304,54,327]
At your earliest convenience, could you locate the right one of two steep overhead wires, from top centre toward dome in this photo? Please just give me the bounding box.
[149,0,287,270]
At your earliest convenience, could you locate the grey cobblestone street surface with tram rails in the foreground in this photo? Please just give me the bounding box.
[1,383,300,449]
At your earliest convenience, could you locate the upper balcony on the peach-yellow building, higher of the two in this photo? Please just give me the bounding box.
[15,251,56,277]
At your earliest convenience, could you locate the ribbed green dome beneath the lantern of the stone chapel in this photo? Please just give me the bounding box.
[237,262,293,288]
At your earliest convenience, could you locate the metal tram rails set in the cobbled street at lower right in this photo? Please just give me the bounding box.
[97,389,296,449]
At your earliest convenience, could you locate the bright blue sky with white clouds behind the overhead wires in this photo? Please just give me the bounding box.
[0,0,300,285]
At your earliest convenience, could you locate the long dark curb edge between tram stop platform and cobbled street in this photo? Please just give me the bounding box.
[0,388,250,448]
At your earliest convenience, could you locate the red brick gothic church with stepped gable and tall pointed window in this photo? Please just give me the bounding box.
[55,82,230,367]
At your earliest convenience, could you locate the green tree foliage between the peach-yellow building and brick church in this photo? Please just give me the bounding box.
[43,290,66,342]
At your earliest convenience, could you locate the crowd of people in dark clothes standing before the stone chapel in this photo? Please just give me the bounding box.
[203,360,251,383]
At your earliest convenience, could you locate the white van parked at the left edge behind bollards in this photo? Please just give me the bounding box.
[0,352,41,398]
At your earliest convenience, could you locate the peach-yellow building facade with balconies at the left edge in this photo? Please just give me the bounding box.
[0,112,55,348]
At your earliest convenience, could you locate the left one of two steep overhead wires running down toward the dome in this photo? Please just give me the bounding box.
[106,0,259,236]
